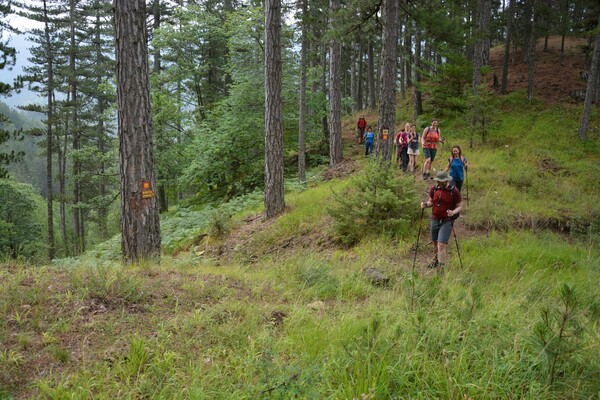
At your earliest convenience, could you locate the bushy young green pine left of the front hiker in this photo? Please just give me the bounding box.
[327,160,418,245]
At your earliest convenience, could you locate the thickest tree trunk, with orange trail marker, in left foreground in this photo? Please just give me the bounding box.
[113,0,160,263]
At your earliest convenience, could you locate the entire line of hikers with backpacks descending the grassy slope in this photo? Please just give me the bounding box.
[357,115,468,270]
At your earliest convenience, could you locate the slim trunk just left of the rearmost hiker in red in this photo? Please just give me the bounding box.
[329,0,342,167]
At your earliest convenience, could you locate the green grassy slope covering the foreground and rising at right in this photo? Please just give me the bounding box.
[0,93,600,399]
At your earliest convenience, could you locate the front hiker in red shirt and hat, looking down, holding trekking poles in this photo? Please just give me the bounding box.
[421,171,462,269]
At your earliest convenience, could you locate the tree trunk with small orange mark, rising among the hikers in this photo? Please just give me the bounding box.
[378,0,398,161]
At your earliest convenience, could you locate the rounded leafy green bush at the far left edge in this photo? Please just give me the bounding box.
[0,179,43,258]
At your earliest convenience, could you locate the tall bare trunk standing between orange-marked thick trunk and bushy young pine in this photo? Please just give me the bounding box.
[265,0,285,218]
